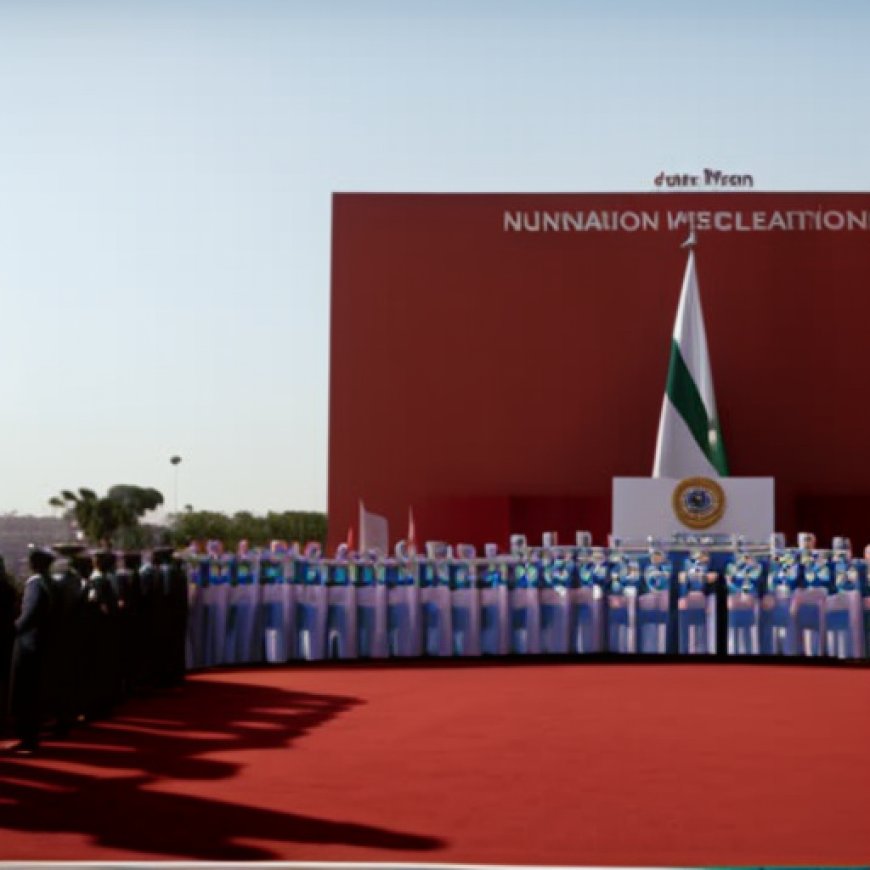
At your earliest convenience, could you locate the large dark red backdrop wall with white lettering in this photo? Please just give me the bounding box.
[328,193,870,546]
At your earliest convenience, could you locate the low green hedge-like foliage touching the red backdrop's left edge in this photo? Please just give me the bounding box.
[172,510,327,548]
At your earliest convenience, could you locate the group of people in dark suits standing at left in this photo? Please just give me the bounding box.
[0,544,188,754]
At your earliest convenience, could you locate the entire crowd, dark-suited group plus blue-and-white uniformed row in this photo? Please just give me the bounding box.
[0,535,870,753]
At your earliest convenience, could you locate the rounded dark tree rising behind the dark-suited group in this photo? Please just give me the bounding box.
[48,484,163,548]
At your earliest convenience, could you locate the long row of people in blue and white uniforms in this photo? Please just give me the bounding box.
[186,544,870,668]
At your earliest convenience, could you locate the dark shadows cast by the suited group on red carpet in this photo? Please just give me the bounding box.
[0,675,442,860]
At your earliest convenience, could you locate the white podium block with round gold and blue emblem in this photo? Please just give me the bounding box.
[611,477,774,543]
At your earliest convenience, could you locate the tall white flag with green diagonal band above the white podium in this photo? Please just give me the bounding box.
[653,235,728,478]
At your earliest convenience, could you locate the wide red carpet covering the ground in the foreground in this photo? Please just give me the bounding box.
[0,663,870,865]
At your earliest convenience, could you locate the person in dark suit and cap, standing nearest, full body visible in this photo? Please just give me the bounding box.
[11,547,54,755]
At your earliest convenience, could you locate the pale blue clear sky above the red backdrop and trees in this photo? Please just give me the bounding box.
[0,0,870,513]
